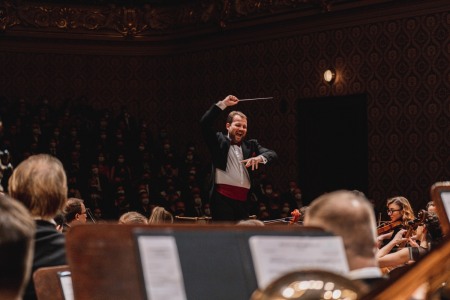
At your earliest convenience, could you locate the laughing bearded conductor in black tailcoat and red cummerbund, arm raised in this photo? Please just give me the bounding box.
[200,95,277,221]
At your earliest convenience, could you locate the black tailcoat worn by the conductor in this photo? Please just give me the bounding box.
[200,104,277,196]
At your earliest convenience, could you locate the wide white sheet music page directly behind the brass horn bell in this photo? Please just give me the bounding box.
[249,236,349,289]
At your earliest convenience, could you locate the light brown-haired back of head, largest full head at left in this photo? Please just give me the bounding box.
[9,154,67,219]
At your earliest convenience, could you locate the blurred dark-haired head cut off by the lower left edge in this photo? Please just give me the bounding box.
[0,193,36,299]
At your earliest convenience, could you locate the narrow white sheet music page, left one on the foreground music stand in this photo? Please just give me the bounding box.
[138,236,186,300]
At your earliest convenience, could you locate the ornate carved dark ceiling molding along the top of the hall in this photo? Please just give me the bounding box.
[0,0,372,40]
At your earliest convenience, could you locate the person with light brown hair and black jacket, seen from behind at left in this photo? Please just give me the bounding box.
[9,154,67,299]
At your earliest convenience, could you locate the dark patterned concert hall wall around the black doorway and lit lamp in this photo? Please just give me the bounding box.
[0,1,450,212]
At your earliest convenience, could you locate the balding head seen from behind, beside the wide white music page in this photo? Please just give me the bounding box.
[304,190,377,270]
